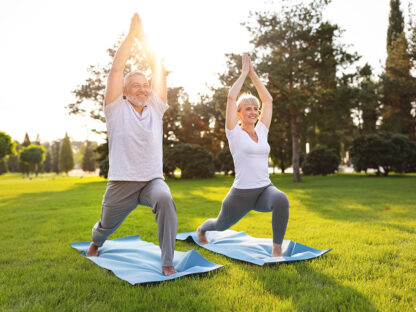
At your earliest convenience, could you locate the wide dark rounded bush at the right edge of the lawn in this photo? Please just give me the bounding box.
[350,132,416,176]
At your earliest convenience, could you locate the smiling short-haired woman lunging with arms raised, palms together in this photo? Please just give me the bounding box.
[197,54,289,257]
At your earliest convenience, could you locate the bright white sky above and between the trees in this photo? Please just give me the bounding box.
[0,0,411,142]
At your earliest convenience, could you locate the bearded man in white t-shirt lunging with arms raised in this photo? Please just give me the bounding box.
[87,13,177,276]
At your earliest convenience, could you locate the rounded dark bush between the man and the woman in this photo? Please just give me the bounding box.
[163,143,215,179]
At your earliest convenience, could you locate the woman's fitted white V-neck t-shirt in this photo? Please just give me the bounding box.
[225,121,271,189]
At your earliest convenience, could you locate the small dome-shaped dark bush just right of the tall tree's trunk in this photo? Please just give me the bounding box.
[302,146,340,175]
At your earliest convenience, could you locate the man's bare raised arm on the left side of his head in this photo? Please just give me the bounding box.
[105,13,141,105]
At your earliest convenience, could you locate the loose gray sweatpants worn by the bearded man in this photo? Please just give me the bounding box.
[92,179,177,266]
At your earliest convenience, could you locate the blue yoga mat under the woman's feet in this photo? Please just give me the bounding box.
[176,230,332,265]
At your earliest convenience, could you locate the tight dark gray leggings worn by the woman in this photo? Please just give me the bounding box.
[201,184,289,244]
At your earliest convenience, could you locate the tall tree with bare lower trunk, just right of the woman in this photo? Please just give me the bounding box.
[246,0,357,182]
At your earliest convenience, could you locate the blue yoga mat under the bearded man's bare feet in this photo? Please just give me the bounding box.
[71,235,223,285]
